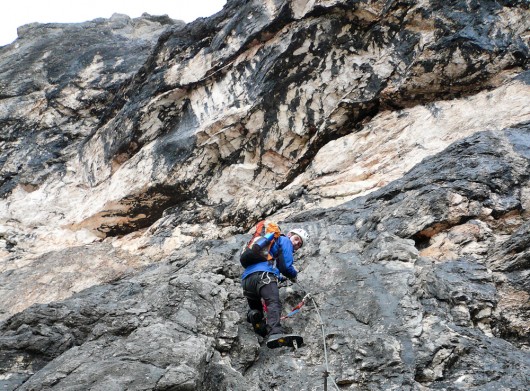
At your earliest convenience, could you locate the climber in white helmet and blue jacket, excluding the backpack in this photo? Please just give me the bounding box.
[241,228,309,348]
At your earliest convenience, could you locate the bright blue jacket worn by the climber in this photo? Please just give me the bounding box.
[241,235,298,280]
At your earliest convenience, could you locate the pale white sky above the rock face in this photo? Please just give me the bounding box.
[0,0,226,46]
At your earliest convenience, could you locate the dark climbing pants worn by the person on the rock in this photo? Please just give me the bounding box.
[241,272,283,334]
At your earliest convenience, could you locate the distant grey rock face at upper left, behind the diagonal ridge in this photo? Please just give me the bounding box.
[0,14,180,195]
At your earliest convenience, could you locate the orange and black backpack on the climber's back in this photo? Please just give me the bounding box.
[239,220,281,267]
